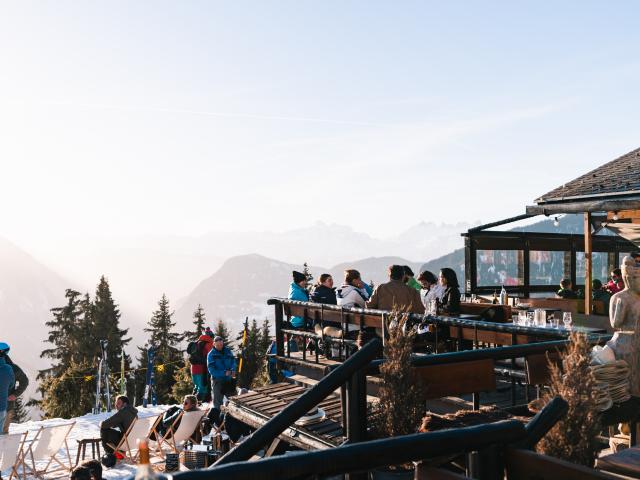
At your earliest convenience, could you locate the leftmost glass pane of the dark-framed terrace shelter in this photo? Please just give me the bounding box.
[476,250,524,287]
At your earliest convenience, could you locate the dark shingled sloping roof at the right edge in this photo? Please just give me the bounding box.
[535,148,640,205]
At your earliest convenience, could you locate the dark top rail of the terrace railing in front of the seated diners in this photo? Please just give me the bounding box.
[267,297,596,338]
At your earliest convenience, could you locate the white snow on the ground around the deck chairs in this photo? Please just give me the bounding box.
[2,405,169,480]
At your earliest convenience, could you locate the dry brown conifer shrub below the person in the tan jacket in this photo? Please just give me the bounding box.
[372,310,425,479]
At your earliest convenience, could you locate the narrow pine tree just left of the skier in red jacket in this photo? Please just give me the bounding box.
[139,294,183,404]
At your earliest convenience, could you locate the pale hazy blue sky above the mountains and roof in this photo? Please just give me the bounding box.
[0,0,640,248]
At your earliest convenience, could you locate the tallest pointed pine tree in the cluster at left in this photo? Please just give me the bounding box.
[91,275,131,373]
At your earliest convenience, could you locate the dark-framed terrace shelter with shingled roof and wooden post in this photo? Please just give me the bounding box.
[464,149,640,312]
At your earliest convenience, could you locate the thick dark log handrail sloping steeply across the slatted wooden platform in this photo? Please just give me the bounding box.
[214,338,382,465]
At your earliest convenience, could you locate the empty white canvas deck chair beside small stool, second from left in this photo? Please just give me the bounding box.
[25,422,76,477]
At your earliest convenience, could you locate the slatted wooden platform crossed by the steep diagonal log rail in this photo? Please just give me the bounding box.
[227,383,352,450]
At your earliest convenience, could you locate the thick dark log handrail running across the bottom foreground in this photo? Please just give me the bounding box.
[176,420,526,480]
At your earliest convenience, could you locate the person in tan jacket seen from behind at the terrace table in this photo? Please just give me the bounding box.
[367,265,424,313]
